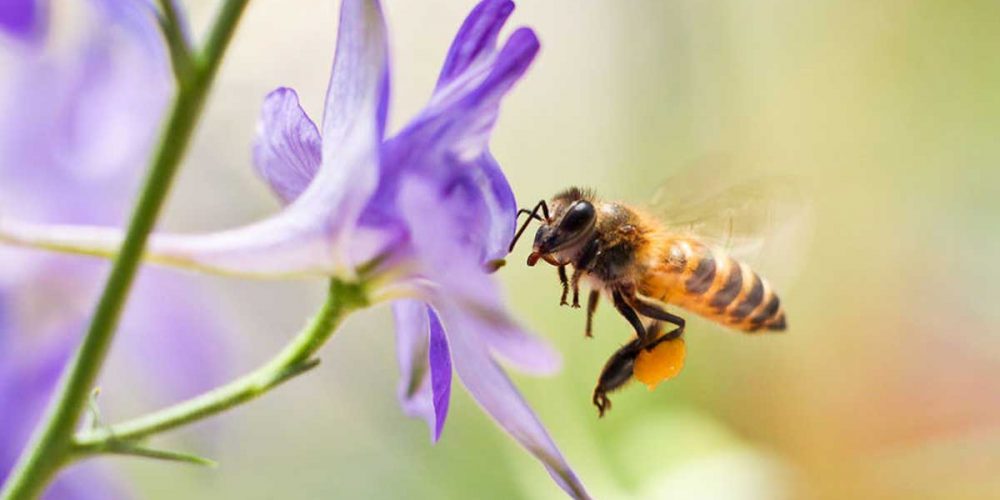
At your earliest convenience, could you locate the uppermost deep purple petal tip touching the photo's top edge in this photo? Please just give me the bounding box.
[438,0,514,88]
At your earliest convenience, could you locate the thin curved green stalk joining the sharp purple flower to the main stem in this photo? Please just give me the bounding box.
[76,280,368,448]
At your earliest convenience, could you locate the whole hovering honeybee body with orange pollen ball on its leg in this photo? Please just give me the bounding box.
[510,182,787,417]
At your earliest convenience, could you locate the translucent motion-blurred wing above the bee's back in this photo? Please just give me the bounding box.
[650,158,812,283]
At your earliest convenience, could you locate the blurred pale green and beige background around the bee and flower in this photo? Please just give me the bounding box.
[1,0,1000,499]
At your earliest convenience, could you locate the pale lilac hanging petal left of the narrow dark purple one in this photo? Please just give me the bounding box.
[392,300,436,432]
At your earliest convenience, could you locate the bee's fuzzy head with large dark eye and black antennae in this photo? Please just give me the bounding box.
[511,188,597,266]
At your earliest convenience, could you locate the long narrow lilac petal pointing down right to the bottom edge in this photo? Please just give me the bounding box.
[435,303,589,498]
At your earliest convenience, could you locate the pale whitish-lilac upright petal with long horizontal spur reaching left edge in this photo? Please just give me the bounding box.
[0,0,388,277]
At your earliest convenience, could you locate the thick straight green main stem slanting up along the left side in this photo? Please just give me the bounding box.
[0,0,249,500]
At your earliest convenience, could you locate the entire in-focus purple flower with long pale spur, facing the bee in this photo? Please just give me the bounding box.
[0,0,587,497]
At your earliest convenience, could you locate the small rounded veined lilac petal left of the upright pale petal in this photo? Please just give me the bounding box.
[253,87,321,204]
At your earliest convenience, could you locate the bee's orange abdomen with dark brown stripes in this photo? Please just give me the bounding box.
[642,239,786,332]
